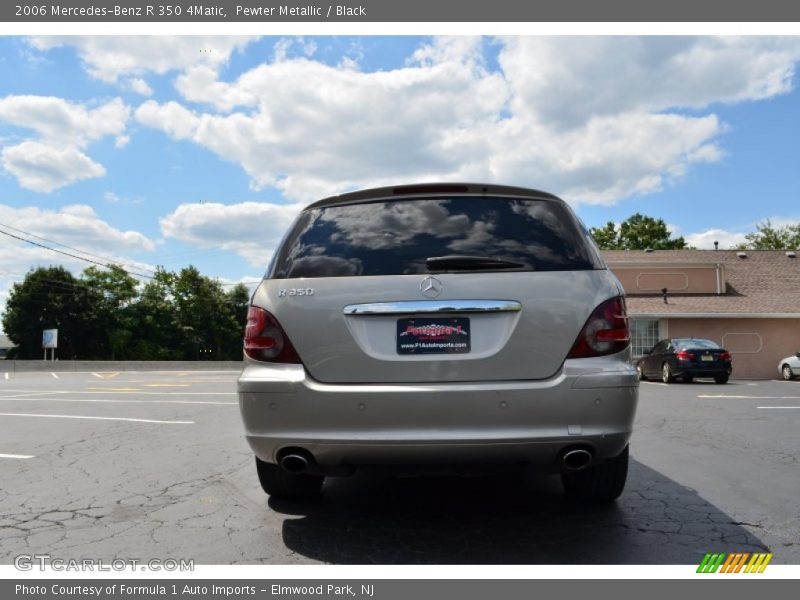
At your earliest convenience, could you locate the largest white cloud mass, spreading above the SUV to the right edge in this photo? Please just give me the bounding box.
[136,37,800,203]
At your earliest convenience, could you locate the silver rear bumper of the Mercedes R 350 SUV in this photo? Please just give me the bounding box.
[238,357,638,470]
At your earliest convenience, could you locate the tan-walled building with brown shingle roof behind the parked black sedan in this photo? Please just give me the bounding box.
[603,250,800,379]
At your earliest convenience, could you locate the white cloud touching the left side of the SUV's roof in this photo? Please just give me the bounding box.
[160,202,301,268]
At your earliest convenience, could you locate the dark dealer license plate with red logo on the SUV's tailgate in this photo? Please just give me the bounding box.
[397,317,470,354]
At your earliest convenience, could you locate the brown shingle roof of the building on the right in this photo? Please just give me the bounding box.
[602,250,800,317]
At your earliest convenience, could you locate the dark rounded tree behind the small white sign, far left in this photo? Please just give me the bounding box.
[2,266,94,359]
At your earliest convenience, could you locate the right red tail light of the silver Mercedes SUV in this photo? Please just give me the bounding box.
[567,296,631,358]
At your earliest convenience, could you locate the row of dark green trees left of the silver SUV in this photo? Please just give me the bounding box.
[2,266,249,360]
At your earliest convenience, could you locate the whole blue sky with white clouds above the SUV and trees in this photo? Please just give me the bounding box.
[0,36,800,318]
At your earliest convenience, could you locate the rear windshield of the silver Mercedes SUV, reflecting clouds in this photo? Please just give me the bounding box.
[271,197,597,279]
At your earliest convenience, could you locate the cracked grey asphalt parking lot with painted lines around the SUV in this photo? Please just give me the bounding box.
[0,371,800,564]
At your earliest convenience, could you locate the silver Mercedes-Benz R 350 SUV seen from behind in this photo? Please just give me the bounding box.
[238,184,638,501]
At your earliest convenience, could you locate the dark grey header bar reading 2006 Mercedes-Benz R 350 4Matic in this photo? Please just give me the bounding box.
[0,0,800,23]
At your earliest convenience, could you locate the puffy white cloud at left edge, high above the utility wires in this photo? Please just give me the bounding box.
[0,96,129,193]
